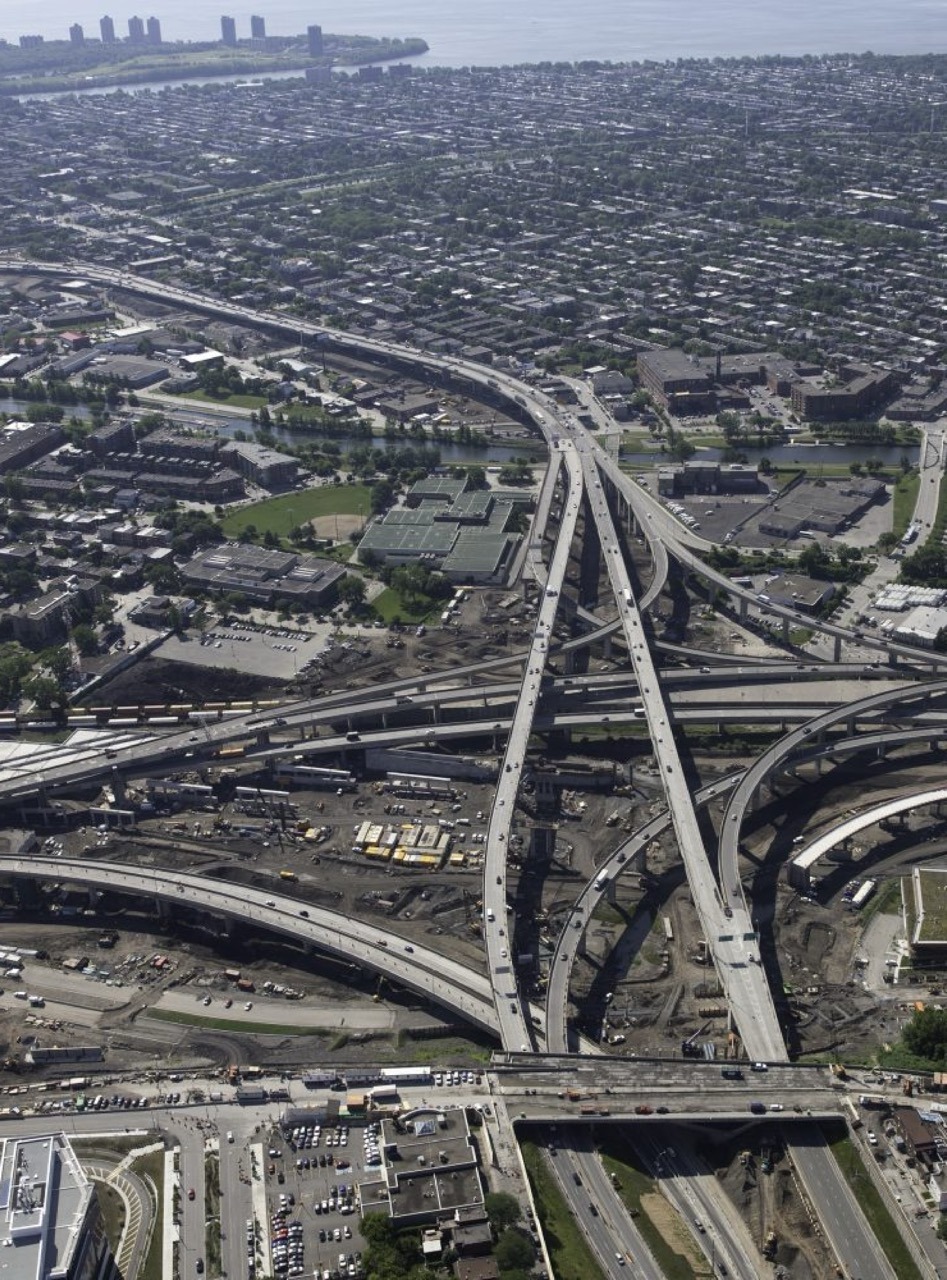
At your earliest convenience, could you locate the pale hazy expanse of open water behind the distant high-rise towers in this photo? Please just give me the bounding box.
[0,0,947,67]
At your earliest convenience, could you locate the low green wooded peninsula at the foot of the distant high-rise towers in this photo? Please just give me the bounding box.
[0,36,429,97]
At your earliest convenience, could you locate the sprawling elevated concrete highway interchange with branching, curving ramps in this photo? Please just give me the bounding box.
[0,261,947,1280]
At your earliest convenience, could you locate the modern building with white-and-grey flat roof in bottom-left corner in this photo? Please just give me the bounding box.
[0,1133,119,1280]
